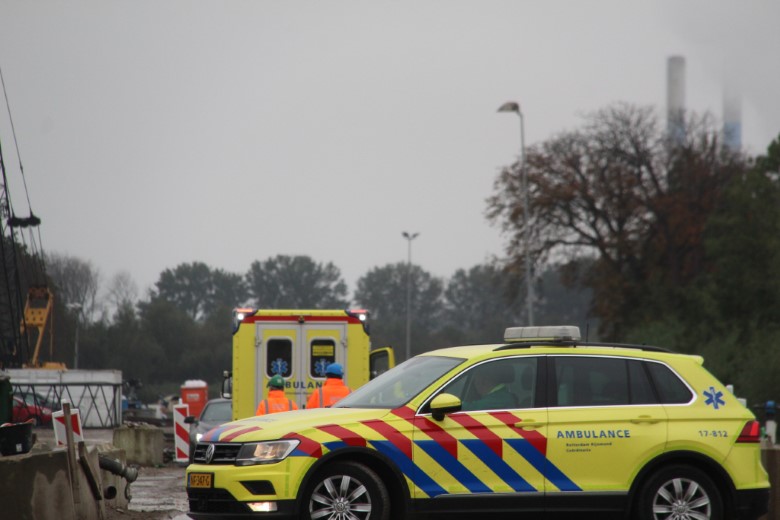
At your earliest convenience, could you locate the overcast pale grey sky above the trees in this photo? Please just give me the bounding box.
[0,0,780,298]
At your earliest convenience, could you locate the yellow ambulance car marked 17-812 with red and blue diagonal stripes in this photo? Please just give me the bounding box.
[186,327,769,520]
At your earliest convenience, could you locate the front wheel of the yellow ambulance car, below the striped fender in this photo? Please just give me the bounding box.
[301,462,390,520]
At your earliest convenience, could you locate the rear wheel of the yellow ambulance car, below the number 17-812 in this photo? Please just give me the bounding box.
[636,465,723,520]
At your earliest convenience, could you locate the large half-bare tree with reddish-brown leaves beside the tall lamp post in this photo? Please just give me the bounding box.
[488,104,744,338]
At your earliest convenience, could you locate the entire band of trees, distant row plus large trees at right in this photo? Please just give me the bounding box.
[1,104,780,410]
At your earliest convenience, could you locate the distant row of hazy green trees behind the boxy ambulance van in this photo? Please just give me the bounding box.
[29,255,589,399]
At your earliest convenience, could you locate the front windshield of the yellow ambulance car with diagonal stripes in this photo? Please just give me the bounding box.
[333,356,465,408]
